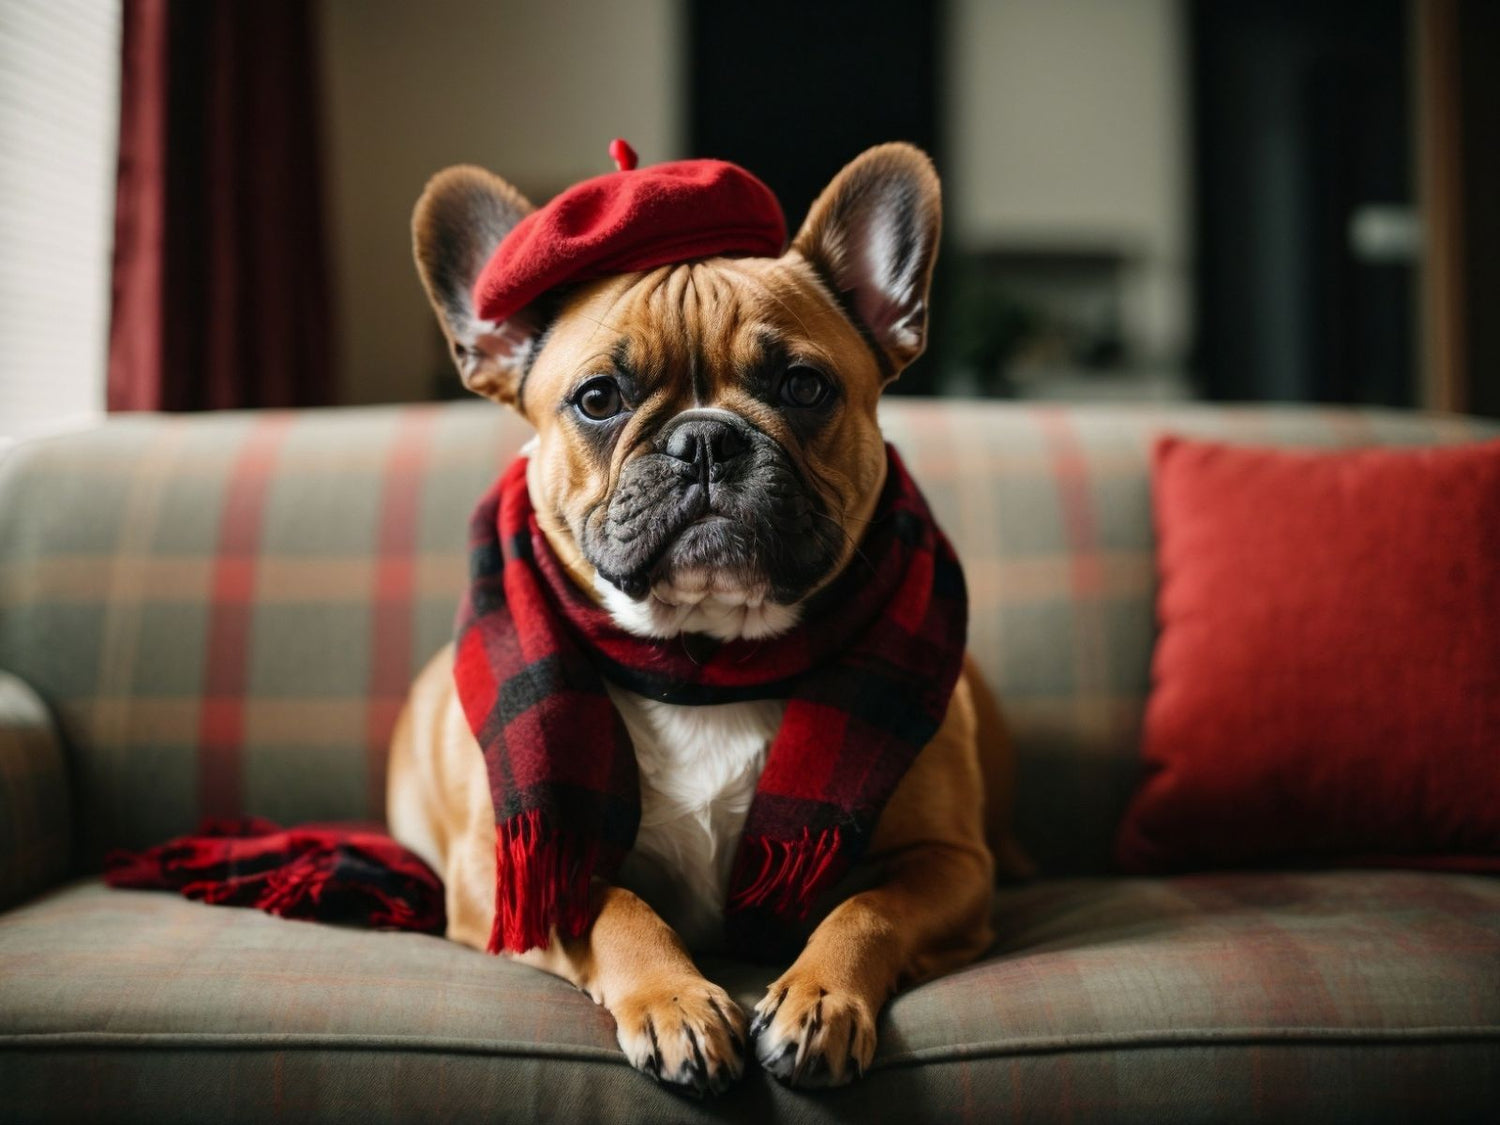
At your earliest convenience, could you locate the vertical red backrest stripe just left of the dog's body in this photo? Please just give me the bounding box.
[365,407,438,819]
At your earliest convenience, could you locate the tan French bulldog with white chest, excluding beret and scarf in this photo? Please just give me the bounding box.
[389,144,1025,1095]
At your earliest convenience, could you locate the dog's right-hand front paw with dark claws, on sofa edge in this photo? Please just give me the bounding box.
[750,969,876,1088]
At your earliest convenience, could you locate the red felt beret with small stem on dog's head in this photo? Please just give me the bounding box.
[474,141,786,321]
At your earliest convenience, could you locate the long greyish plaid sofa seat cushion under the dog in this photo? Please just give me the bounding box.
[0,872,1500,1124]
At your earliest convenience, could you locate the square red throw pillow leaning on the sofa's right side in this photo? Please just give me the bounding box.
[1116,438,1500,872]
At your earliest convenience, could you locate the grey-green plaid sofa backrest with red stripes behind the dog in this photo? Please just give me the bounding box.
[0,399,1500,873]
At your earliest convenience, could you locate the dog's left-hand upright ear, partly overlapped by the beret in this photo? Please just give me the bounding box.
[411,165,539,405]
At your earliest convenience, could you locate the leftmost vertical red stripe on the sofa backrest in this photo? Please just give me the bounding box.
[198,414,294,816]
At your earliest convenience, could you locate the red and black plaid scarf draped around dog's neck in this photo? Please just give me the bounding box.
[455,446,968,954]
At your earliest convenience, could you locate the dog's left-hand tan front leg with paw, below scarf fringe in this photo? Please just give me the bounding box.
[516,884,746,1097]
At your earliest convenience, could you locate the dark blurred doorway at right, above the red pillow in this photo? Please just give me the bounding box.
[1190,0,1416,407]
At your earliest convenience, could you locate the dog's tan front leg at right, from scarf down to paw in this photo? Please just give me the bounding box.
[750,683,995,1086]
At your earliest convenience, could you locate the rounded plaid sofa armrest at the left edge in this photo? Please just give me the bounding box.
[0,672,72,909]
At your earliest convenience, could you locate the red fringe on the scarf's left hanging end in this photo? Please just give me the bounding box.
[488,809,599,954]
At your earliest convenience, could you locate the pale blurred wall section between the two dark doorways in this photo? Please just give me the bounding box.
[948,0,1191,363]
